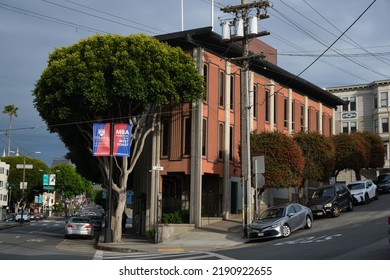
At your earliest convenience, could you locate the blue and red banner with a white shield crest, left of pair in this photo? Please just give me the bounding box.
[93,123,111,157]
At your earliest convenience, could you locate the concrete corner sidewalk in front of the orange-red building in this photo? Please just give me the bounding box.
[96,220,248,252]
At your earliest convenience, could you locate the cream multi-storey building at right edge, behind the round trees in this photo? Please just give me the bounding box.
[326,80,390,183]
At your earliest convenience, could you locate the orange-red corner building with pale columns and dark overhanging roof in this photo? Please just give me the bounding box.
[133,28,343,233]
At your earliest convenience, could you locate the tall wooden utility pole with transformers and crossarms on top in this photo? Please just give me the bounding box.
[221,0,271,238]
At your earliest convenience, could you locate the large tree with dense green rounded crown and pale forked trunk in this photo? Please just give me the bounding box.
[33,35,204,242]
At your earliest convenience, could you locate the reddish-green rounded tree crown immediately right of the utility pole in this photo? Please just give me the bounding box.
[251,131,304,188]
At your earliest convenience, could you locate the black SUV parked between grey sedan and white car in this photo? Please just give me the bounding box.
[306,183,353,217]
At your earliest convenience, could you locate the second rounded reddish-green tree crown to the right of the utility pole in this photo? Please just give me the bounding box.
[293,132,335,181]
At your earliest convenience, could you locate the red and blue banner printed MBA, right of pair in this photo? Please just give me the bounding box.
[113,123,131,157]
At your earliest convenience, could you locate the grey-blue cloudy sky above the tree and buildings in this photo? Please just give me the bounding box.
[0,0,390,166]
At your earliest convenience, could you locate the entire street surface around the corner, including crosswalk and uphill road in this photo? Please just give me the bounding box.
[0,194,390,260]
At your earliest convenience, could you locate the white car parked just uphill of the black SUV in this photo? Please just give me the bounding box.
[347,180,379,204]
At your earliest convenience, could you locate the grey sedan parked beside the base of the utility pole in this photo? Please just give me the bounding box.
[249,203,313,239]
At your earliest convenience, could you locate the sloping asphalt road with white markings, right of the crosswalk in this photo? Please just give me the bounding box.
[218,194,390,260]
